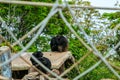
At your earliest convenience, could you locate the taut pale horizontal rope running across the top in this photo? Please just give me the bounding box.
[0,0,120,10]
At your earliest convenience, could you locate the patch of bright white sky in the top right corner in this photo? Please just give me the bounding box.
[83,0,120,13]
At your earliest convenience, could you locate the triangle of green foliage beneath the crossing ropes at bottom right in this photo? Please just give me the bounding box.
[81,64,117,80]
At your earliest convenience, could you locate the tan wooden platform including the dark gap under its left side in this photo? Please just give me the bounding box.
[11,51,74,79]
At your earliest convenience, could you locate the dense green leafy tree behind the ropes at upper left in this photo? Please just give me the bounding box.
[0,0,69,51]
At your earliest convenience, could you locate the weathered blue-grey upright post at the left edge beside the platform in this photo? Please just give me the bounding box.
[0,46,12,80]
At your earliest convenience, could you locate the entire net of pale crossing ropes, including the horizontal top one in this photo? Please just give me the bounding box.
[0,0,120,80]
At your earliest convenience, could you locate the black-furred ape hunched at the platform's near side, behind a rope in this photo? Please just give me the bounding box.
[30,51,51,73]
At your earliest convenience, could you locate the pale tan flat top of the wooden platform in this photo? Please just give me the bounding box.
[12,51,72,71]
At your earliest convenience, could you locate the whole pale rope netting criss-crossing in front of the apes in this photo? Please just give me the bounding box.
[0,0,120,80]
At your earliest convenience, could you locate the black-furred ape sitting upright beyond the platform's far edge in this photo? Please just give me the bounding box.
[50,35,68,52]
